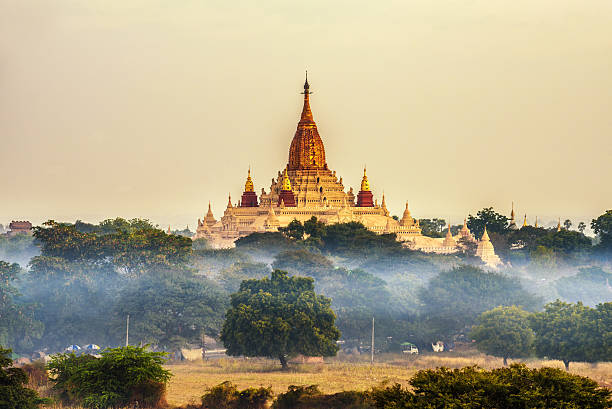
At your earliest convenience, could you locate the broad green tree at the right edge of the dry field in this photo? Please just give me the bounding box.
[530,300,612,370]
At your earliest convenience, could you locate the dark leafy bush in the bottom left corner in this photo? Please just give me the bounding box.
[0,347,47,409]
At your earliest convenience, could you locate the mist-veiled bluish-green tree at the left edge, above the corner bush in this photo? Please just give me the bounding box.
[0,261,43,350]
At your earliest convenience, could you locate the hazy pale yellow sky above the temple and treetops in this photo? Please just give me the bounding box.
[0,0,612,229]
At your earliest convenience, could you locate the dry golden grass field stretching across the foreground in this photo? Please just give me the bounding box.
[167,353,612,406]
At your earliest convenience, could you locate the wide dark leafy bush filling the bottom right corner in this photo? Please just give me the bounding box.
[371,364,612,409]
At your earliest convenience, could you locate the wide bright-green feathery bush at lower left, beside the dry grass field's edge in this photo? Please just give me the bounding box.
[48,346,172,408]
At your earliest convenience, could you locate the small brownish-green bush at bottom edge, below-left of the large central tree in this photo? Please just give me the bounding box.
[202,381,272,409]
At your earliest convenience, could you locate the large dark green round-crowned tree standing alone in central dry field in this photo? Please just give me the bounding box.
[221,270,340,368]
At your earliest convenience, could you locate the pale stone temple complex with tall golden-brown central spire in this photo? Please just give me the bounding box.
[194,78,498,267]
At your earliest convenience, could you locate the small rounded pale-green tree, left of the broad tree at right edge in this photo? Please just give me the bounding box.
[470,306,534,366]
